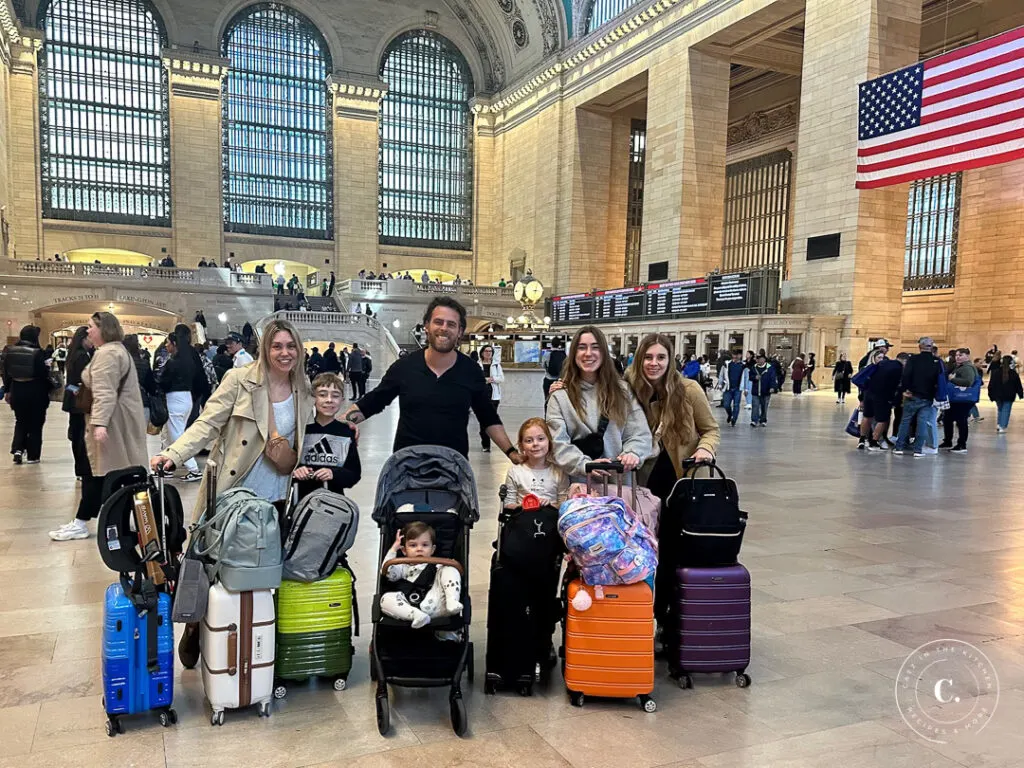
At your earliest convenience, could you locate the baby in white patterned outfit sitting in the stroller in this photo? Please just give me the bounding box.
[381,521,462,640]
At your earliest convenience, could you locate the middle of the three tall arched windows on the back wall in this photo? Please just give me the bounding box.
[223,3,334,240]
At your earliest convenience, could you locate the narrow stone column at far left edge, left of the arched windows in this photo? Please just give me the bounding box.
[6,32,43,259]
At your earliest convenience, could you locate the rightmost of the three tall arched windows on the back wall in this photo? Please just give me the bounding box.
[379,30,473,250]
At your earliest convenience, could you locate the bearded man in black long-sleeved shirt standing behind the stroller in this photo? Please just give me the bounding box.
[345,296,519,464]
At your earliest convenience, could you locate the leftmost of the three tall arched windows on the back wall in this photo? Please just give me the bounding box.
[39,0,171,226]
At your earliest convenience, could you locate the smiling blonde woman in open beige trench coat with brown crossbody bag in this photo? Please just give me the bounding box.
[150,318,313,669]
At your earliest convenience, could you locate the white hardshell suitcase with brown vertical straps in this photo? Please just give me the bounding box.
[200,583,275,725]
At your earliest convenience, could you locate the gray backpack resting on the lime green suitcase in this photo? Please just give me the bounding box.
[284,488,359,582]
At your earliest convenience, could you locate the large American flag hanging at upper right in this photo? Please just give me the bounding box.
[857,27,1024,189]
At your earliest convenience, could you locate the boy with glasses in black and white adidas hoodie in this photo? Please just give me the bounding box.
[292,373,362,499]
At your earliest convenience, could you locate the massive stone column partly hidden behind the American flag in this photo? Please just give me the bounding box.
[783,0,921,349]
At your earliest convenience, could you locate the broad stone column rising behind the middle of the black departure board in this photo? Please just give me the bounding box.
[640,48,729,282]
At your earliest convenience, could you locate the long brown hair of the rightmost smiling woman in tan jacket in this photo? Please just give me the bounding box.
[626,334,700,450]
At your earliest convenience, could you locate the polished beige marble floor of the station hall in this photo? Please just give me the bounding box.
[0,392,1024,768]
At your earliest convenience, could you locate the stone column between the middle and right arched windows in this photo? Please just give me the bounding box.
[330,73,387,280]
